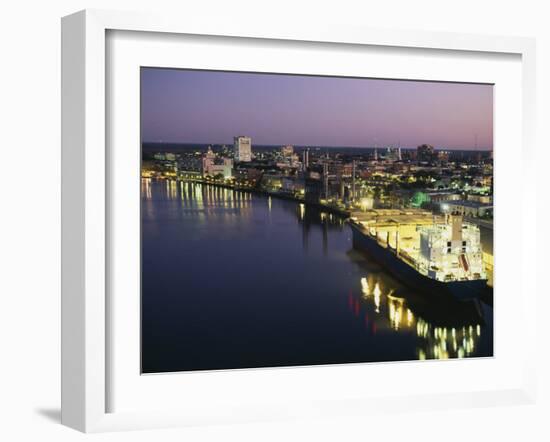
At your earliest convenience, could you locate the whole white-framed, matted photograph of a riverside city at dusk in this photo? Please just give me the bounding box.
[62,11,536,432]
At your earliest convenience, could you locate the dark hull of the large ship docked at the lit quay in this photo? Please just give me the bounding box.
[350,223,487,299]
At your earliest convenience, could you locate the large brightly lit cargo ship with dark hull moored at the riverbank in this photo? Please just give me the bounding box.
[350,209,487,299]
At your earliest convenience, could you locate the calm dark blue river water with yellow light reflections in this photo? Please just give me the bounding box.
[142,180,493,373]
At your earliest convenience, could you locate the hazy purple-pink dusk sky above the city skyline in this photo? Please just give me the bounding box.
[141,68,493,149]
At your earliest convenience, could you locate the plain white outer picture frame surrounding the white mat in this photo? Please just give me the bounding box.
[62,10,537,432]
